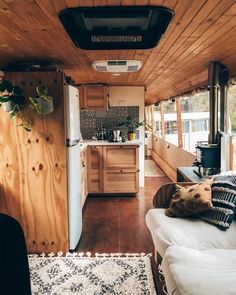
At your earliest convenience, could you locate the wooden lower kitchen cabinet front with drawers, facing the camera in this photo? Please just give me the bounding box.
[88,145,139,193]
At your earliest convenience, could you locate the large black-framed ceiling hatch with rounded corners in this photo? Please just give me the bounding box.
[59,6,174,50]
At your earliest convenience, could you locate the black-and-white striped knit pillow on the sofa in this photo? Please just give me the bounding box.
[199,174,236,230]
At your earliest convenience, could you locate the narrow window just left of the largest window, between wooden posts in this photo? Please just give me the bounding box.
[164,101,178,145]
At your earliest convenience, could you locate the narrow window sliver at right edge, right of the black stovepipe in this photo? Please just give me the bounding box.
[228,86,236,170]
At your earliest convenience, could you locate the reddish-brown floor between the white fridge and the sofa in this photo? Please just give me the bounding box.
[77,177,170,253]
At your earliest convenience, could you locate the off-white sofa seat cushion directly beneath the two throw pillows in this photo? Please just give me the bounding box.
[146,209,236,256]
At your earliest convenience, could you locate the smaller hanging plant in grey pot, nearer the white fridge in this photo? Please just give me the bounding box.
[29,86,53,115]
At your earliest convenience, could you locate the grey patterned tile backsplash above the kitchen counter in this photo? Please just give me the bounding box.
[80,106,139,139]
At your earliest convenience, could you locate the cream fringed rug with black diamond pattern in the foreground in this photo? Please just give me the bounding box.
[29,253,156,295]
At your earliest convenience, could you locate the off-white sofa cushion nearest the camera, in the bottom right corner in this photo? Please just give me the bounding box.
[162,246,236,295]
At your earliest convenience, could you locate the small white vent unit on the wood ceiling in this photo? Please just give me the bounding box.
[92,60,143,73]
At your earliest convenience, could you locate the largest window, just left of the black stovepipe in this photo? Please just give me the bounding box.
[181,92,209,153]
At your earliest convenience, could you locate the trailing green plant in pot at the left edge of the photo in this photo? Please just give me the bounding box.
[0,71,32,131]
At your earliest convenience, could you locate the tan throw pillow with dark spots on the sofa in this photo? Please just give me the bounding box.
[165,180,212,217]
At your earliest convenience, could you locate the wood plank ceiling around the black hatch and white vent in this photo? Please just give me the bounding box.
[0,0,236,104]
